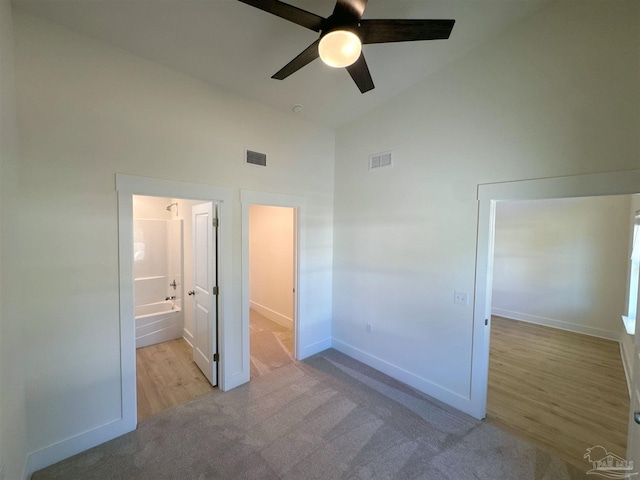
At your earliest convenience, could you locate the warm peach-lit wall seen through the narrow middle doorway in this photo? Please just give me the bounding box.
[249,205,294,327]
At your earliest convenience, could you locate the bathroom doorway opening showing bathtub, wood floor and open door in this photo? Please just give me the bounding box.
[133,195,217,421]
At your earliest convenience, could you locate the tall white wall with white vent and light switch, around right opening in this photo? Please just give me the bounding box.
[333,0,640,410]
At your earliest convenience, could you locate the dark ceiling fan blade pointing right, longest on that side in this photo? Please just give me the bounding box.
[359,20,456,44]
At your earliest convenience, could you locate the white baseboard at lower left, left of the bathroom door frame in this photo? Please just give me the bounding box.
[26,418,136,479]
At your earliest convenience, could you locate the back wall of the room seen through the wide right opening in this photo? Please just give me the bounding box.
[492,195,631,341]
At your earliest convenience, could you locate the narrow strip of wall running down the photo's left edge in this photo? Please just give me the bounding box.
[0,0,27,479]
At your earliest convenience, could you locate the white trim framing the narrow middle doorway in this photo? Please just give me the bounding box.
[240,190,307,372]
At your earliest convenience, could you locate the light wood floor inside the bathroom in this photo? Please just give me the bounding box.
[136,338,213,422]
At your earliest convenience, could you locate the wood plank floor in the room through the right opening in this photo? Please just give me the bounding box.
[486,317,629,471]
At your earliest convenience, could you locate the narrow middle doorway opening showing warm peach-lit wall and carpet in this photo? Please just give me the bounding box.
[249,204,297,379]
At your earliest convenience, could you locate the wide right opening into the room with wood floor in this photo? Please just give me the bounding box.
[487,195,633,470]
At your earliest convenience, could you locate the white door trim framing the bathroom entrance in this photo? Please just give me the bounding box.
[116,174,234,431]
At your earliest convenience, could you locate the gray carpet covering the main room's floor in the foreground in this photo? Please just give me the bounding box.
[32,350,588,480]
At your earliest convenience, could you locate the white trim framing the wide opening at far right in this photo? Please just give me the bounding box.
[469,170,640,419]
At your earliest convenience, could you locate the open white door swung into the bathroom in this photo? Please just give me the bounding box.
[189,202,218,386]
